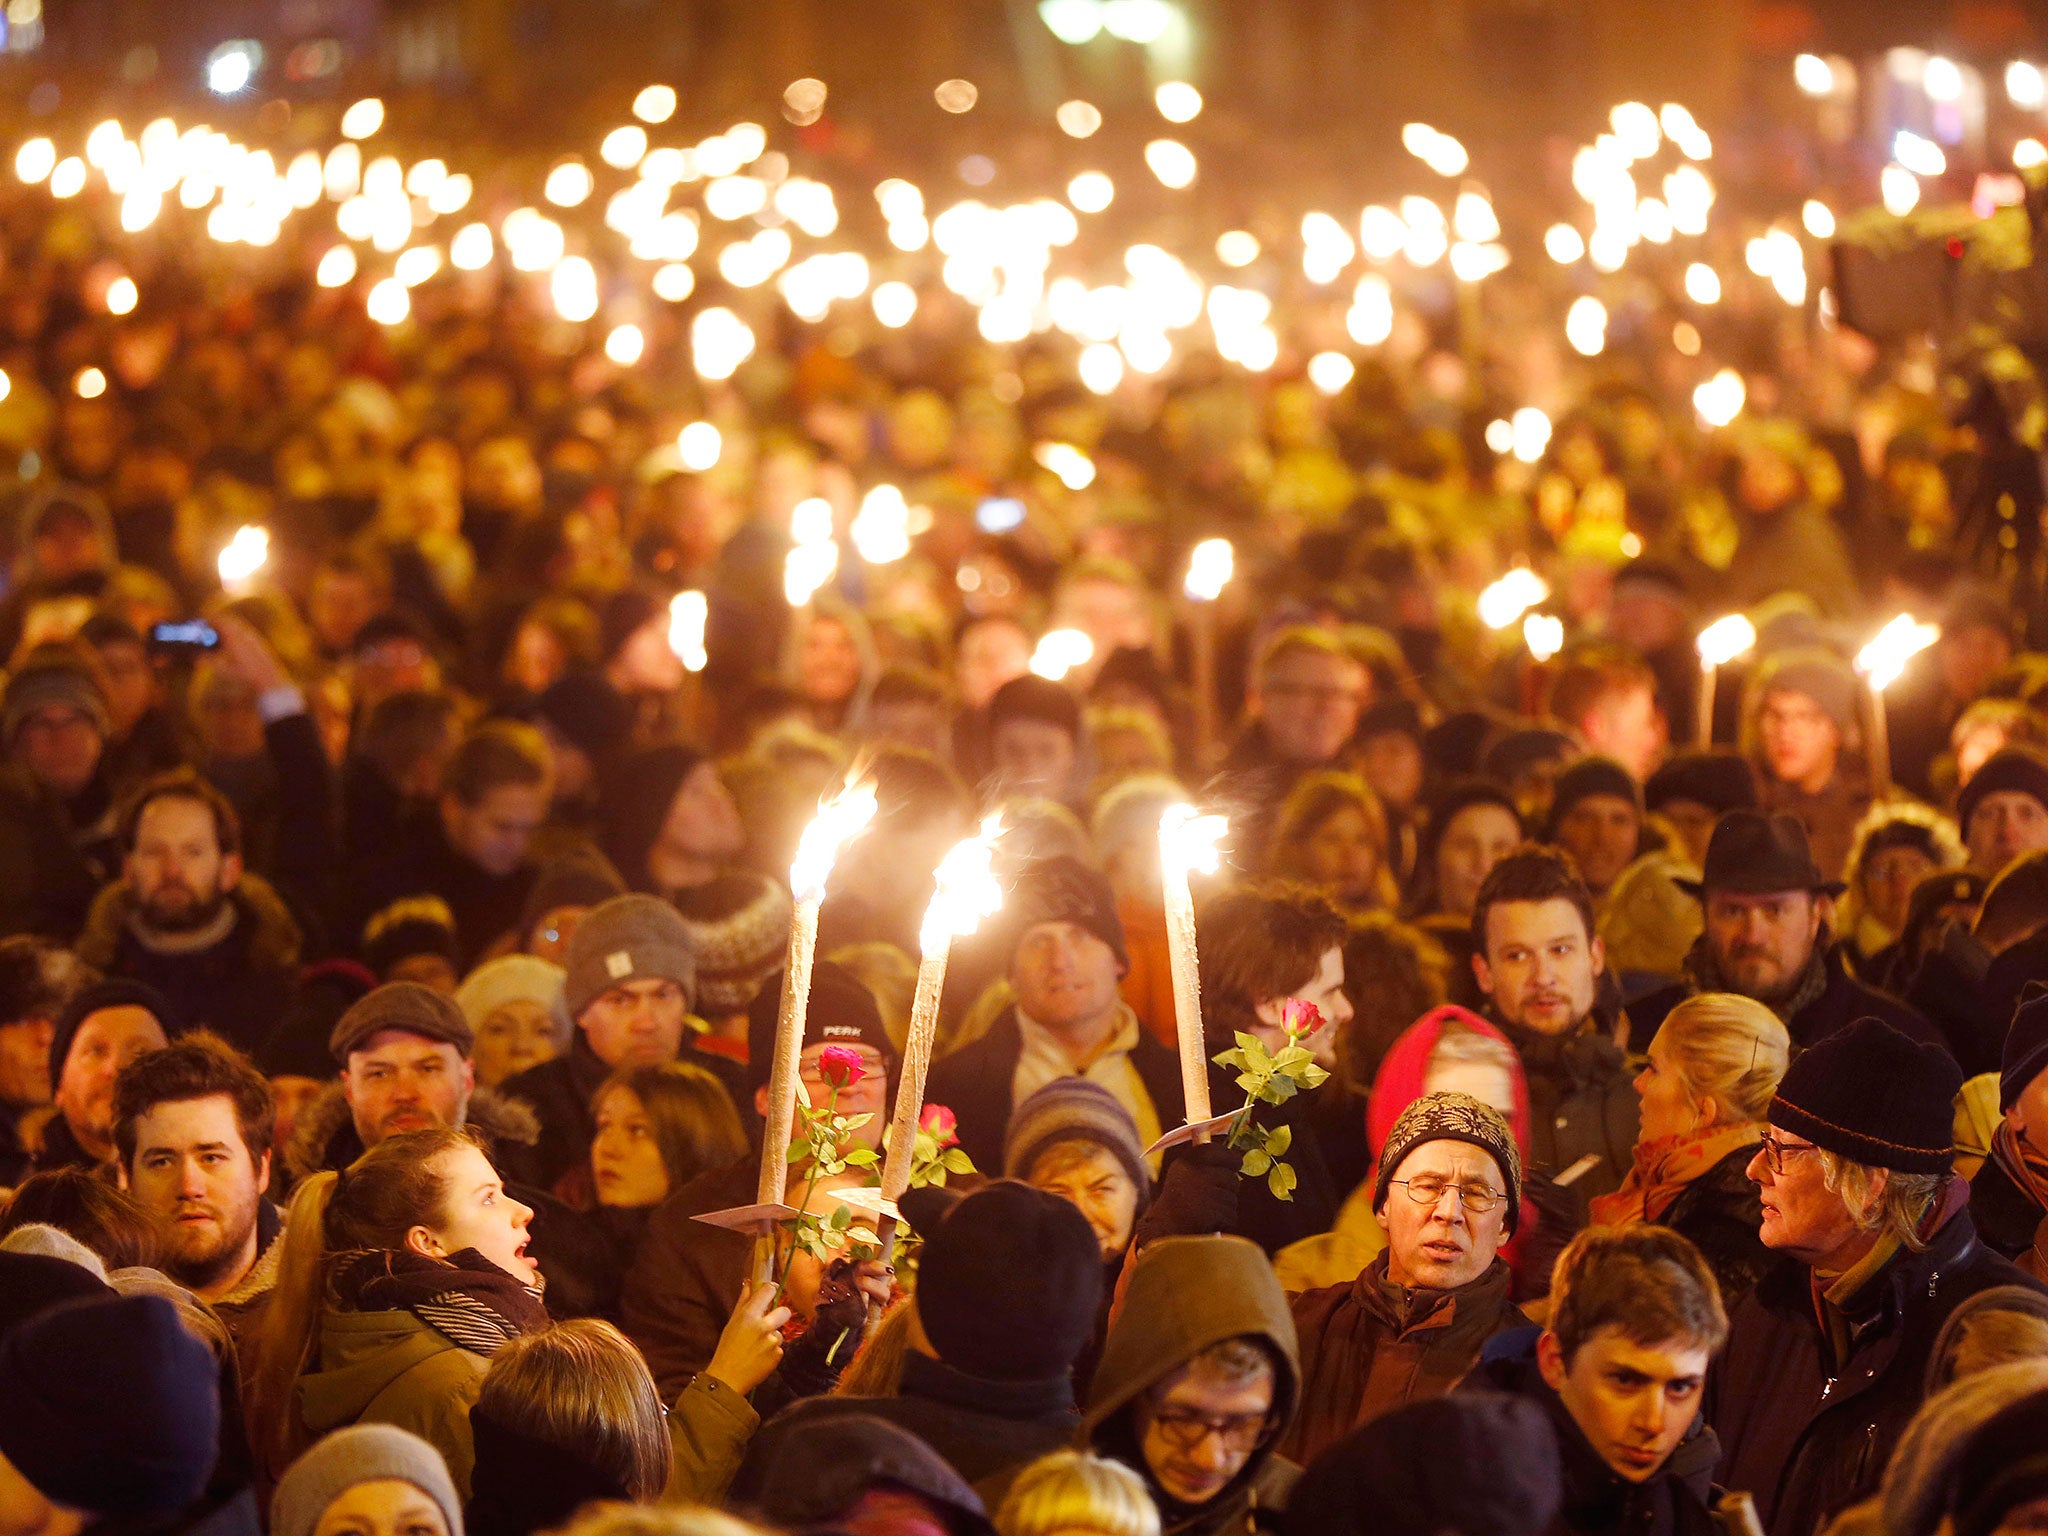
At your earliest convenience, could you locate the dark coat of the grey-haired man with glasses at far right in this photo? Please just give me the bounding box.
[1708,1210,2040,1536]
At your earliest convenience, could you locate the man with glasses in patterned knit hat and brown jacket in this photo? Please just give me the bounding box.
[1280,1094,1528,1464]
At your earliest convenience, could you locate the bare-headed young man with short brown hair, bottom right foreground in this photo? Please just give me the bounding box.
[1466,1227,1729,1536]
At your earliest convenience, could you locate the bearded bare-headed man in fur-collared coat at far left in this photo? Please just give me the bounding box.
[78,768,299,1051]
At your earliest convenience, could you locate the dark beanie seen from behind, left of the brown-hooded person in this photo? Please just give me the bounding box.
[901,1180,1102,1382]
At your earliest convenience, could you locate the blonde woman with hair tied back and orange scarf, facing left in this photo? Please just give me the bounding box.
[1591,991,1792,1307]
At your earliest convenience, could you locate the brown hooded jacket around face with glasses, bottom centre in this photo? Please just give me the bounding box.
[1081,1237,1300,1536]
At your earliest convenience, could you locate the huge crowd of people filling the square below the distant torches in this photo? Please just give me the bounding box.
[0,81,2048,1536]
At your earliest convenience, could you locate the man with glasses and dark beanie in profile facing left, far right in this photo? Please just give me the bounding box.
[1708,1018,2040,1536]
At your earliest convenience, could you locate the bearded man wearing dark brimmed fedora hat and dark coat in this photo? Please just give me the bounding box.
[1628,811,1948,1051]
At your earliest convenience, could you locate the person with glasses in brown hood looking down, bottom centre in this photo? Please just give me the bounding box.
[1081,1237,1300,1536]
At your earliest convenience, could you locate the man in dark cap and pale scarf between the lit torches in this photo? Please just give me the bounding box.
[924,854,1184,1169]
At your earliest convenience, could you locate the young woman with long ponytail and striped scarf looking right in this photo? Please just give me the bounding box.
[246,1128,547,1499]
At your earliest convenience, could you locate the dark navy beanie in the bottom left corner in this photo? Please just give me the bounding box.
[0,1296,221,1518]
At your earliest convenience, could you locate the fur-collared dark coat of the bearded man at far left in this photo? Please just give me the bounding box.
[76,874,299,1053]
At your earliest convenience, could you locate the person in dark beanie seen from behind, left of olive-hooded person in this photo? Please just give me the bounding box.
[733,1180,1102,1503]
